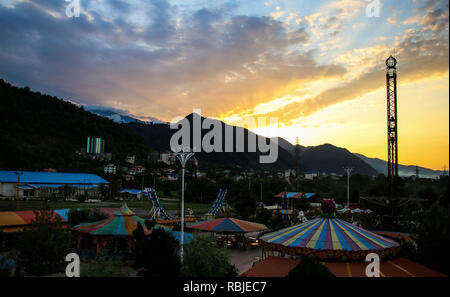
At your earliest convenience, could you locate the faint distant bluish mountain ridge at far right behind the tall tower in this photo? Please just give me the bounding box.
[353,153,443,178]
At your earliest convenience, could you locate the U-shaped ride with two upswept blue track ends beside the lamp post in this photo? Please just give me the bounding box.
[143,188,227,224]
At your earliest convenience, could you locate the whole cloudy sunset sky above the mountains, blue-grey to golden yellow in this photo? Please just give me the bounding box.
[0,0,449,170]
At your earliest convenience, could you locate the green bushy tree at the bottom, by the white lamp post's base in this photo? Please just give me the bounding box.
[180,236,237,277]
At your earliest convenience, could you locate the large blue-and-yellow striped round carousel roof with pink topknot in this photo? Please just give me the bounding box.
[260,218,399,260]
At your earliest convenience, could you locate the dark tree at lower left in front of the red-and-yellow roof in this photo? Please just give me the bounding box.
[17,205,76,276]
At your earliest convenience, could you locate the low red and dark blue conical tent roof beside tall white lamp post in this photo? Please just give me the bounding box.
[189,217,267,233]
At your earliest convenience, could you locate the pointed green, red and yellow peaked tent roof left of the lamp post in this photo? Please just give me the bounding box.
[73,202,151,236]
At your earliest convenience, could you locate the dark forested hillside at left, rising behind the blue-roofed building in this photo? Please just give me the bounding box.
[0,79,149,171]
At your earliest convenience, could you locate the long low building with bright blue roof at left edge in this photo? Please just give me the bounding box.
[0,171,109,198]
